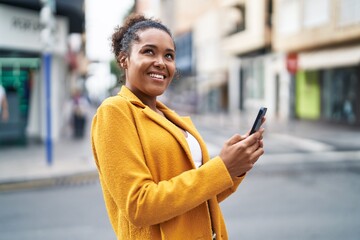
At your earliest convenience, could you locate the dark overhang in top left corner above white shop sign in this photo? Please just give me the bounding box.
[0,0,85,33]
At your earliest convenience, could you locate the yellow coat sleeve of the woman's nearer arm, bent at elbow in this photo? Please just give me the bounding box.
[92,104,234,226]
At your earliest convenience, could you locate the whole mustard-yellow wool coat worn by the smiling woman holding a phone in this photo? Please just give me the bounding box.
[91,86,243,240]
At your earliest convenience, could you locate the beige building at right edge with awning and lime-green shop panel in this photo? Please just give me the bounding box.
[273,0,360,126]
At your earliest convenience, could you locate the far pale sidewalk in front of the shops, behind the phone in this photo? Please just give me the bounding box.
[192,113,360,151]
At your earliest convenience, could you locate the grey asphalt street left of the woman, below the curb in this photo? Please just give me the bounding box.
[0,183,115,240]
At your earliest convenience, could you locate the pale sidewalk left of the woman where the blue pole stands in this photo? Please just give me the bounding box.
[0,129,98,191]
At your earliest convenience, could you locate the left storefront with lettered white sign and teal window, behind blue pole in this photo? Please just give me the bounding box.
[0,4,69,145]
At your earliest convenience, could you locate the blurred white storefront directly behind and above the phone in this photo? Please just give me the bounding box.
[229,53,291,121]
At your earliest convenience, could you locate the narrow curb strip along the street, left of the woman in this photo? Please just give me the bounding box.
[0,171,99,193]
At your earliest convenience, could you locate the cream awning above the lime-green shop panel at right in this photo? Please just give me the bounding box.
[298,45,360,70]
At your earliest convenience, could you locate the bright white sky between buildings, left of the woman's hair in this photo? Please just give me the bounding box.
[85,0,133,101]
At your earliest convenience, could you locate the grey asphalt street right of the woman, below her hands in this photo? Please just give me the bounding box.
[222,159,360,240]
